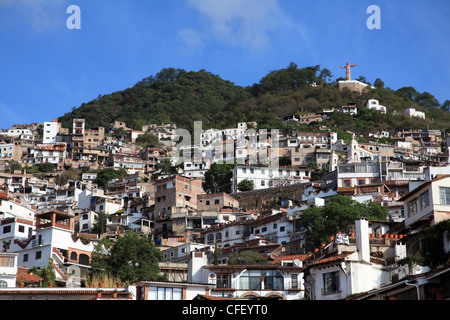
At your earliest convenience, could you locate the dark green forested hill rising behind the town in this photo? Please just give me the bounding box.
[59,63,450,134]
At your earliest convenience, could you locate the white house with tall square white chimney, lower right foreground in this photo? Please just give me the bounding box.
[305,219,406,300]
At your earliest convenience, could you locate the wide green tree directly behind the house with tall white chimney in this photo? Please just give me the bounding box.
[301,195,388,249]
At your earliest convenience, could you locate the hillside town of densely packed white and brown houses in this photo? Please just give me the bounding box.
[0,99,450,300]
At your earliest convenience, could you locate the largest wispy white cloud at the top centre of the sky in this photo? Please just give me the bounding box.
[187,0,307,50]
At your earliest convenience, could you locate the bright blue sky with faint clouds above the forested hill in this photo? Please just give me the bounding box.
[0,0,450,129]
